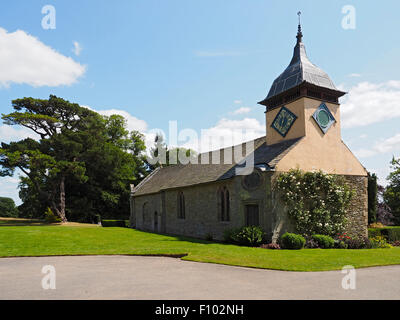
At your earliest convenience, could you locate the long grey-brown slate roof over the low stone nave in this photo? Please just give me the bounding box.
[132,136,301,196]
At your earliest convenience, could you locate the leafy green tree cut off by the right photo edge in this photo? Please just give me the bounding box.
[384,157,400,225]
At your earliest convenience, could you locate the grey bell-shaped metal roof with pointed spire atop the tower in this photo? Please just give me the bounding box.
[259,14,345,105]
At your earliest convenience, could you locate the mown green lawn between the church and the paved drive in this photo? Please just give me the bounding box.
[0,223,400,271]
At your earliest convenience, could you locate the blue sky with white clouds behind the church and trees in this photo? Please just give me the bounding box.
[0,0,400,202]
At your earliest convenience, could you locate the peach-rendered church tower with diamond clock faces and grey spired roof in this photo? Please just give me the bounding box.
[259,12,366,176]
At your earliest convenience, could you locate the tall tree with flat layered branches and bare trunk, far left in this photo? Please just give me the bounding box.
[0,96,99,222]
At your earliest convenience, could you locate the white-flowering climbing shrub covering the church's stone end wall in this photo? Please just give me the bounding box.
[276,169,352,237]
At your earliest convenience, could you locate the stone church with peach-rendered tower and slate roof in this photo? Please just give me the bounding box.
[130,20,368,241]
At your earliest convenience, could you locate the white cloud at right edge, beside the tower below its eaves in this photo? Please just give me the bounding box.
[341,80,400,128]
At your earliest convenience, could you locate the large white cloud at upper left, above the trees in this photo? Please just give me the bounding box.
[0,28,86,87]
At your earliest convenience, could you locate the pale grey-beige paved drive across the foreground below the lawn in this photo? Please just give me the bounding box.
[0,256,400,299]
